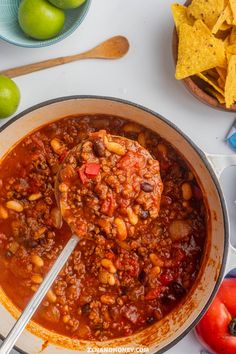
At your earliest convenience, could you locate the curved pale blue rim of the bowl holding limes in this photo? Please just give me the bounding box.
[0,0,92,48]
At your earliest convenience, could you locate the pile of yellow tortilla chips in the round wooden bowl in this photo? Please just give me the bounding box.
[172,0,236,108]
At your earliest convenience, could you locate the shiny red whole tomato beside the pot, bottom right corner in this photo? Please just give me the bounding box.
[195,278,236,354]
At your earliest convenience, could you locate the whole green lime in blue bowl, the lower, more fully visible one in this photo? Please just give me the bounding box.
[18,0,65,40]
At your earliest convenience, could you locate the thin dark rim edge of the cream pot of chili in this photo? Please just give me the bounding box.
[0,95,229,354]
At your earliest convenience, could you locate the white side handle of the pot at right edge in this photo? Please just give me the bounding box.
[206,154,236,274]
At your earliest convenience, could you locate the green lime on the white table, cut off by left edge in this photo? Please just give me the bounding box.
[0,75,20,118]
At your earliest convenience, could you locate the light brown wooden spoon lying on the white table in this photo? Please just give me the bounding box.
[0,36,129,77]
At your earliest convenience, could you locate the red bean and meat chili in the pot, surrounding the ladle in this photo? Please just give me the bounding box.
[0,115,206,341]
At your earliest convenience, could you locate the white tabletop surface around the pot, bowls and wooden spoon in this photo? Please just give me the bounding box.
[0,0,236,354]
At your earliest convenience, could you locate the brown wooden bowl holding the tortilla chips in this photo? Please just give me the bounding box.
[172,0,236,112]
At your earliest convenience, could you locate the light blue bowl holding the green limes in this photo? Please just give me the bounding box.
[0,0,91,48]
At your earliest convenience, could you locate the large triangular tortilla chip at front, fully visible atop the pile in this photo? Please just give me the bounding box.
[175,20,226,80]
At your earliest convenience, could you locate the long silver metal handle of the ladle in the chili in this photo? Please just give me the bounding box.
[0,235,79,354]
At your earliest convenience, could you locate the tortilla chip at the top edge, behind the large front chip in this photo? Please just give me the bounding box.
[188,0,225,29]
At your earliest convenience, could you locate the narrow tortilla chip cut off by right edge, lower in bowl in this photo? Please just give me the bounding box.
[225,55,236,108]
